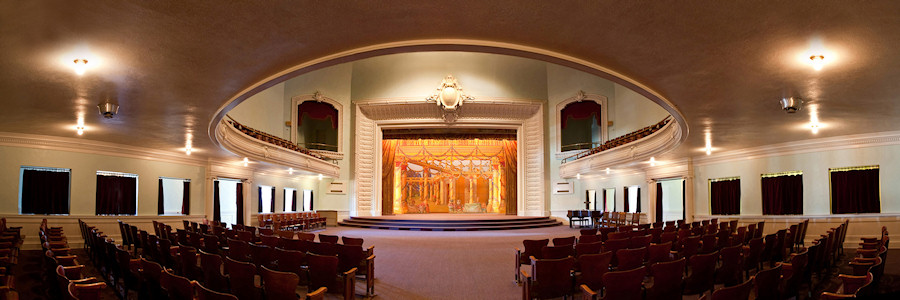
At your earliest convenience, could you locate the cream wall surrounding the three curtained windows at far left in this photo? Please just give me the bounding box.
[0,146,206,216]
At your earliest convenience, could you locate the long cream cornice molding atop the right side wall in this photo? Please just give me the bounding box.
[693,131,900,166]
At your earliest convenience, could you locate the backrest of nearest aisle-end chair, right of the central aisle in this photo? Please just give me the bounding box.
[531,257,575,298]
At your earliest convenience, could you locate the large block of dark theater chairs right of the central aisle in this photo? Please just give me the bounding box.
[516,219,824,299]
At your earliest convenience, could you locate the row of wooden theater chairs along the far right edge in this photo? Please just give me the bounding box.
[819,227,890,300]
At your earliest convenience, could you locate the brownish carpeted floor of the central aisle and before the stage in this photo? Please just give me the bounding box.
[13,226,900,299]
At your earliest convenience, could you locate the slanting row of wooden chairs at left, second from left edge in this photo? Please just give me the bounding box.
[39,219,106,300]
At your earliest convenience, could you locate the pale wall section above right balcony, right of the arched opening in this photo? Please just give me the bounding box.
[608,84,669,139]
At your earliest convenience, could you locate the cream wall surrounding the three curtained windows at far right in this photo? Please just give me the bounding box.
[694,145,900,216]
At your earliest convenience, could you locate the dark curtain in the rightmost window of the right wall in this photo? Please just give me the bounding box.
[831,169,881,214]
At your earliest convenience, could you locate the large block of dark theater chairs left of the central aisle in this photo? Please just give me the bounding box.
[120,218,374,299]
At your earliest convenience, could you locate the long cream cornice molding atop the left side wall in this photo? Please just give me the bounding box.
[0,132,207,167]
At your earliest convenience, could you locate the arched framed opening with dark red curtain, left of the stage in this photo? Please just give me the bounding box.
[291,93,343,152]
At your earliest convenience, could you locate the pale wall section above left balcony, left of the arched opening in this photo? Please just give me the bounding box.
[228,82,291,139]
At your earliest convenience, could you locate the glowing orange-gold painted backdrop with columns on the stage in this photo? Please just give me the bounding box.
[382,139,517,214]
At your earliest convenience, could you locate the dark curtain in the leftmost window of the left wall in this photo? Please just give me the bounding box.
[22,170,69,214]
